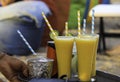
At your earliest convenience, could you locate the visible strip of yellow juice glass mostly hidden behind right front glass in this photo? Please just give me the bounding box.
[92,34,99,77]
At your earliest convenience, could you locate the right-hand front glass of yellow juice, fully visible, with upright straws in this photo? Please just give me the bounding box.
[75,35,96,81]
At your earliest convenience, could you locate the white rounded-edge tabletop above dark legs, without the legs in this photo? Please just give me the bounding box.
[89,4,120,17]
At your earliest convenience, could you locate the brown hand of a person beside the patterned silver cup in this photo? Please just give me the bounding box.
[0,53,28,82]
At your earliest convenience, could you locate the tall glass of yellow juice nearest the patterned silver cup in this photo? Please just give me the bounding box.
[54,36,74,78]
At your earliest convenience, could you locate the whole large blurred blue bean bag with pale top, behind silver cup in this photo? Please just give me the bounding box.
[0,1,51,55]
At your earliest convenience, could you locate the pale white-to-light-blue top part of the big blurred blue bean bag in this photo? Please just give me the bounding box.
[0,1,52,27]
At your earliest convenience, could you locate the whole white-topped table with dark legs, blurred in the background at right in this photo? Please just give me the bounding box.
[89,4,120,52]
